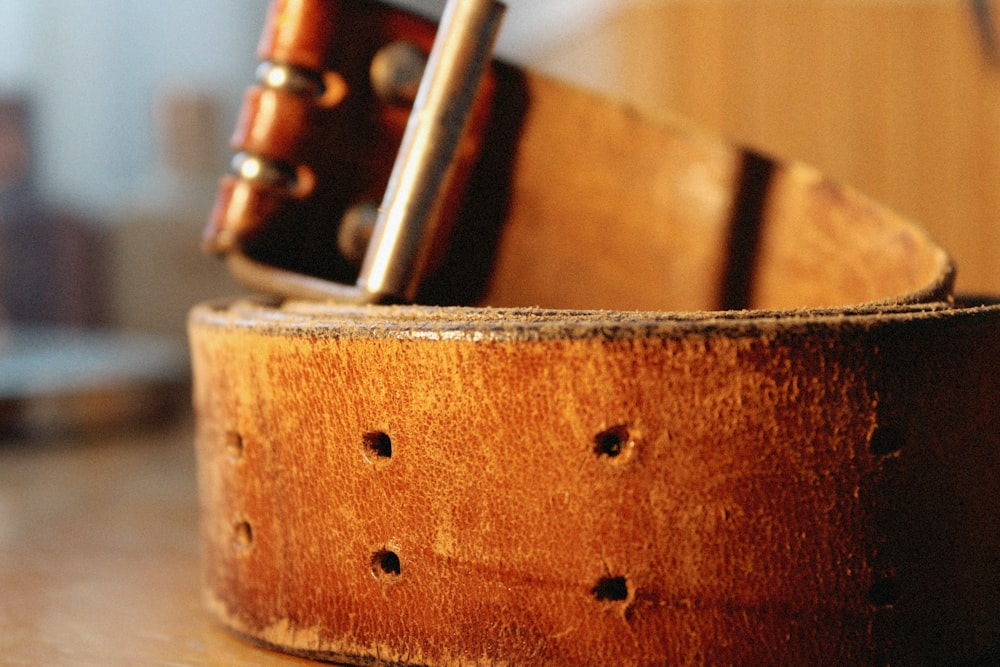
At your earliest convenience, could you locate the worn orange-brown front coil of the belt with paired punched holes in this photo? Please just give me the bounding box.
[192,304,1000,665]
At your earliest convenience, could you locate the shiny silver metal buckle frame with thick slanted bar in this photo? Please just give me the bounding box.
[226,0,504,304]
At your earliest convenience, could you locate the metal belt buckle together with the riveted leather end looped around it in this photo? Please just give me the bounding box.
[204,0,504,304]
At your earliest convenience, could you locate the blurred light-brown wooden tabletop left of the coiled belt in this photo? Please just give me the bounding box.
[0,419,314,667]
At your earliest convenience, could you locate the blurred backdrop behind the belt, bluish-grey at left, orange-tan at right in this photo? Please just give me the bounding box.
[0,0,1000,434]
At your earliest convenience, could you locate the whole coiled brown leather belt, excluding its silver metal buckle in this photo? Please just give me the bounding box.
[190,0,1000,665]
